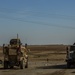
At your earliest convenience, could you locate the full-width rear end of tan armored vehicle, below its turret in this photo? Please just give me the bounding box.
[4,46,21,68]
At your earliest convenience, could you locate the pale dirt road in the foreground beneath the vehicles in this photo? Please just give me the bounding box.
[0,61,75,75]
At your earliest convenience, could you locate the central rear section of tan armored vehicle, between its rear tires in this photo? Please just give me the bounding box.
[8,48,20,67]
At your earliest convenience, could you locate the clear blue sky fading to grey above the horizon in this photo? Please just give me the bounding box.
[0,0,75,45]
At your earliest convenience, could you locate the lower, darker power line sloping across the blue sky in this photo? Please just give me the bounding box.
[0,16,75,29]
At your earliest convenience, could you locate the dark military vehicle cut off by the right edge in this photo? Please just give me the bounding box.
[66,45,75,68]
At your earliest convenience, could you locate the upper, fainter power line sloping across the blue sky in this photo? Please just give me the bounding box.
[0,8,75,20]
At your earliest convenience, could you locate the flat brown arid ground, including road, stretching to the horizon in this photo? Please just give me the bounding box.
[0,45,75,75]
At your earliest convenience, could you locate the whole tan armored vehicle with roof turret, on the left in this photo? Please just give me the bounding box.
[3,38,28,69]
